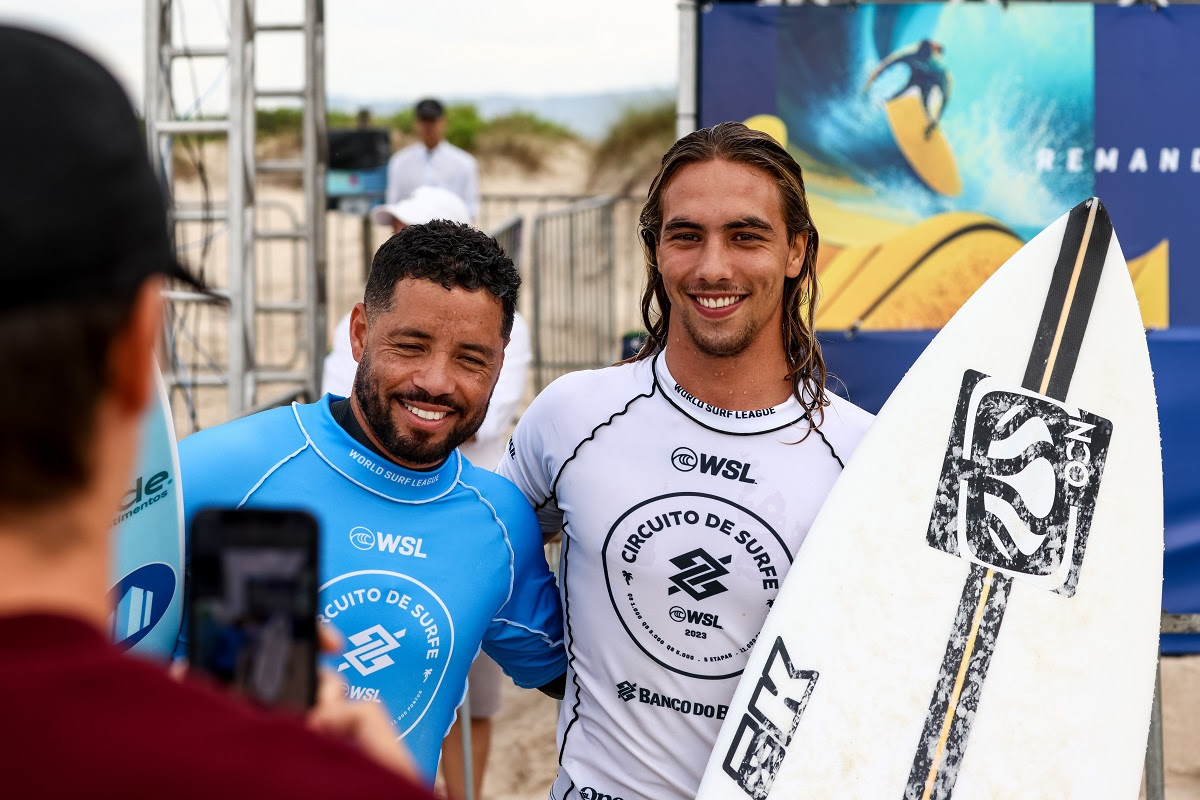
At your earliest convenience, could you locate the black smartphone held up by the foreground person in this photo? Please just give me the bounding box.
[185,509,319,711]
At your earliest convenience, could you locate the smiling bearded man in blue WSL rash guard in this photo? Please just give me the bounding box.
[180,221,566,782]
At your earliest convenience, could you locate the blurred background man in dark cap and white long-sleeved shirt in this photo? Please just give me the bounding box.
[386,98,479,222]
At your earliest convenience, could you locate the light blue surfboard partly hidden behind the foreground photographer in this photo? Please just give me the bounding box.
[109,368,184,661]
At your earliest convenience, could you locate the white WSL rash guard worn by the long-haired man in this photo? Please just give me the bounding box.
[499,354,872,800]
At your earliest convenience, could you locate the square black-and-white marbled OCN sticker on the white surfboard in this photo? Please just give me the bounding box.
[928,371,1112,596]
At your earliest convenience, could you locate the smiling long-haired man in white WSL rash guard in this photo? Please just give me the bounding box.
[500,122,871,800]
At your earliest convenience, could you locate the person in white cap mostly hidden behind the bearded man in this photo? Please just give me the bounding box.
[322,186,533,800]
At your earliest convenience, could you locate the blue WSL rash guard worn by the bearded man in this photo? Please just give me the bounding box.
[179,395,566,783]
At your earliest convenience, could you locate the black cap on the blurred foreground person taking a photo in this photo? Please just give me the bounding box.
[0,25,203,311]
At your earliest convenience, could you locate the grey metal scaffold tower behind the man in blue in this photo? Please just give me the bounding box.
[145,0,328,433]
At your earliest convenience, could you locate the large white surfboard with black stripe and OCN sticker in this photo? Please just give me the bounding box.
[697,198,1163,800]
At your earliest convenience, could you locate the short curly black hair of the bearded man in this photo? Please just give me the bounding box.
[364,219,521,338]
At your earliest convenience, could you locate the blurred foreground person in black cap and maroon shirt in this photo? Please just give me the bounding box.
[0,25,428,799]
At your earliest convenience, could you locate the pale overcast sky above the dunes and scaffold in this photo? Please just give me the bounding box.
[0,0,679,110]
